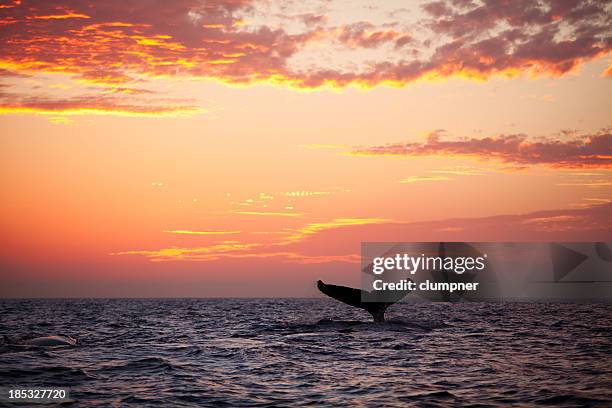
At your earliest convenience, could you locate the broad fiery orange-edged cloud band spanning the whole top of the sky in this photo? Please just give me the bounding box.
[0,0,612,88]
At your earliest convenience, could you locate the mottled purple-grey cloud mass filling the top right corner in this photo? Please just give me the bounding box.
[424,0,612,74]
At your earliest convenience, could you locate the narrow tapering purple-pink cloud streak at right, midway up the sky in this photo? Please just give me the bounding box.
[350,130,612,169]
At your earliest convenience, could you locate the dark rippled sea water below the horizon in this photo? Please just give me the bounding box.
[0,299,612,407]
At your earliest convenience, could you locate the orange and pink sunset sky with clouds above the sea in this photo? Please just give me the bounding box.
[0,0,612,297]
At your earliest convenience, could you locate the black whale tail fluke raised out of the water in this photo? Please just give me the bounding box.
[317,280,410,323]
